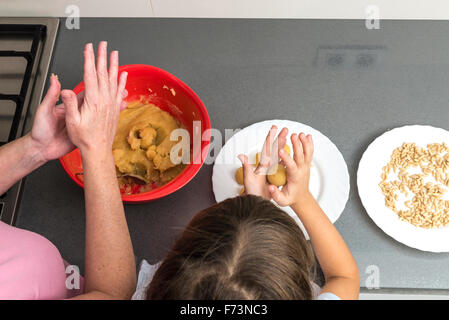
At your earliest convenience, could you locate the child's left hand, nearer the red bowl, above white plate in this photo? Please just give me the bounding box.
[239,126,288,200]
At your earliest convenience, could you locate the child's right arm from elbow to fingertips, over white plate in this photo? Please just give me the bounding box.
[268,133,360,299]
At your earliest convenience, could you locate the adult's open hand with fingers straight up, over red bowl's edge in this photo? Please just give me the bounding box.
[61,41,127,154]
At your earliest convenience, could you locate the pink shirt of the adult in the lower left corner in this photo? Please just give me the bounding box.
[0,222,83,300]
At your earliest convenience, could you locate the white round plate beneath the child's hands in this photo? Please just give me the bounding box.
[212,120,349,239]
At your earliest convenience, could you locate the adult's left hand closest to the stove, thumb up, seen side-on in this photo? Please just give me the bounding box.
[30,75,77,162]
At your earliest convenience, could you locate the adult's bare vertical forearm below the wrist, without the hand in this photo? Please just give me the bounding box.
[70,150,136,299]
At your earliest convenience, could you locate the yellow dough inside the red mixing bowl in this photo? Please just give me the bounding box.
[112,103,184,189]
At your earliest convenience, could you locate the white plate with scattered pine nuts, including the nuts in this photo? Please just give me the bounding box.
[357,125,449,252]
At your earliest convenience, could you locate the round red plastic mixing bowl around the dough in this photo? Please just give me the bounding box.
[59,64,211,203]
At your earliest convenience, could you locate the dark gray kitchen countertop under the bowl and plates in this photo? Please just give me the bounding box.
[17,19,449,289]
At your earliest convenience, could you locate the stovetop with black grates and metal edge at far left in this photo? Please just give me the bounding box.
[0,17,59,225]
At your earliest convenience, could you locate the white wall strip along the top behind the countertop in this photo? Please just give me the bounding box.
[0,0,449,19]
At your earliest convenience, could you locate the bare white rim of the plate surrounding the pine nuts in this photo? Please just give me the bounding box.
[357,125,449,252]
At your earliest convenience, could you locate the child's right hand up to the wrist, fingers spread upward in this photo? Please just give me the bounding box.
[268,133,313,207]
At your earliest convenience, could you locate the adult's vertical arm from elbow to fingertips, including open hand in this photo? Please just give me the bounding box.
[61,42,136,299]
